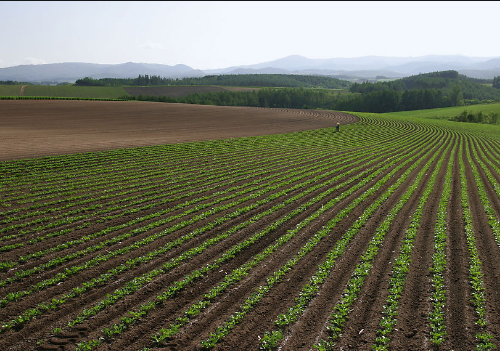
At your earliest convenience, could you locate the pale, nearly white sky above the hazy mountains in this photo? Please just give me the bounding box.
[0,1,500,70]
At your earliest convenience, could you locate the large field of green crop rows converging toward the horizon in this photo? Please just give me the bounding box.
[0,114,500,351]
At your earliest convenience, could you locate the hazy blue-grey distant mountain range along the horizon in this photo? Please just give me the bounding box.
[0,55,500,83]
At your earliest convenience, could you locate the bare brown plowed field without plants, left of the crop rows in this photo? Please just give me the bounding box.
[0,100,358,160]
